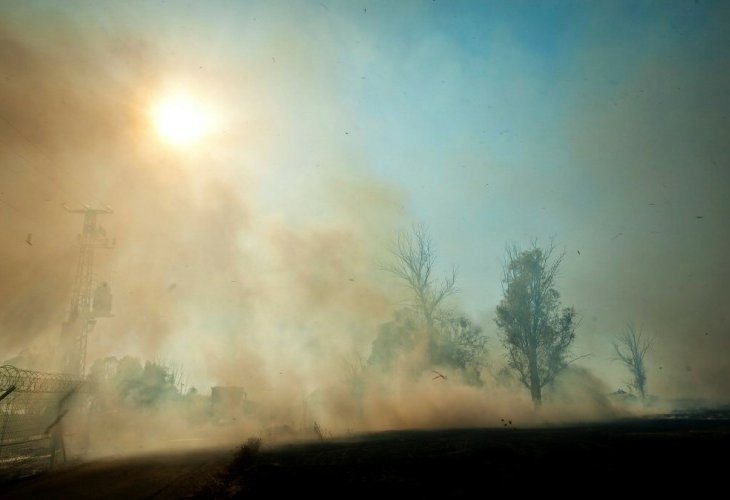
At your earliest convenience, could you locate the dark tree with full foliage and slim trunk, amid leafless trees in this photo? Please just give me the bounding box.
[495,242,578,406]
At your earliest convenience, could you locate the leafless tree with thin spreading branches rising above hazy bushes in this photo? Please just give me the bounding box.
[387,224,456,335]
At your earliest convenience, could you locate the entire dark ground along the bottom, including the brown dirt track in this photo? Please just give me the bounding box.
[5,413,730,499]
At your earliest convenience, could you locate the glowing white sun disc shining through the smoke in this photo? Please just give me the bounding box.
[152,93,212,146]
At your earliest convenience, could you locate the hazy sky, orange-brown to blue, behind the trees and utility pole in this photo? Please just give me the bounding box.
[0,0,730,398]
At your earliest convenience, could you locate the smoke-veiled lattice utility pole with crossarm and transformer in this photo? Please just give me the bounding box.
[61,205,114,377]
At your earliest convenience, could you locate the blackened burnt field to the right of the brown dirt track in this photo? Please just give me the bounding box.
[200,414,730,498]
